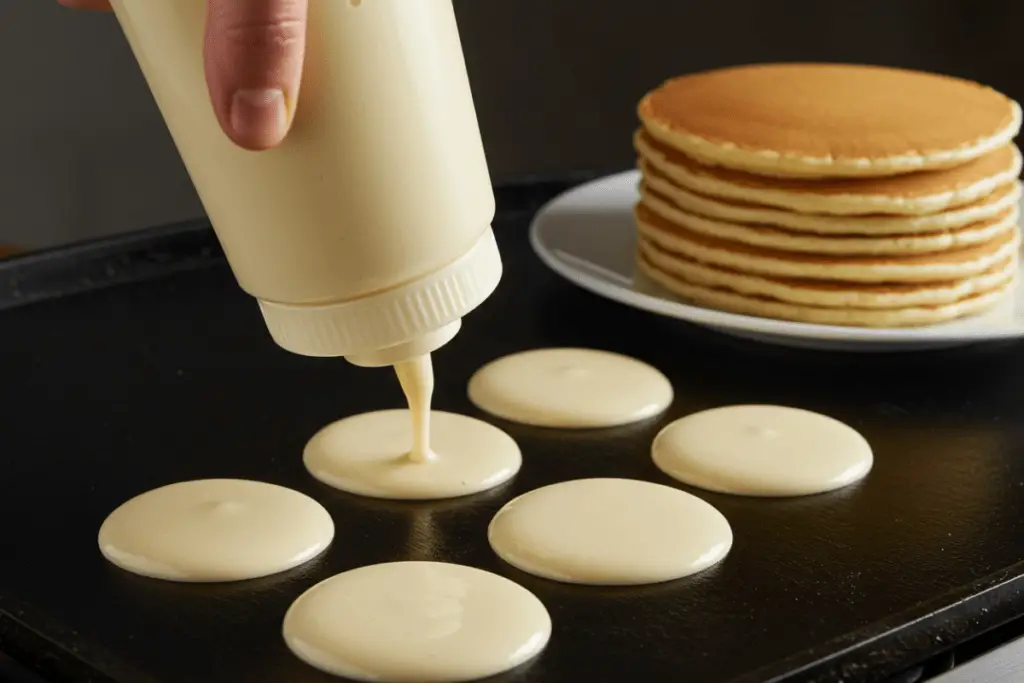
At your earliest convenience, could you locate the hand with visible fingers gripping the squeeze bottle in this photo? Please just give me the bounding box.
[58,0,307,150]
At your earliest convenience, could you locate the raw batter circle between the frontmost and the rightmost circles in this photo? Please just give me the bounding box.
[487,479,732,586]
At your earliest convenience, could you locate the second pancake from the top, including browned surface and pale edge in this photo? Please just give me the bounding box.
[634,130,1021,215]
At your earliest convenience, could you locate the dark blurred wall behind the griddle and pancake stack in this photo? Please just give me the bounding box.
[0,0,1024,247]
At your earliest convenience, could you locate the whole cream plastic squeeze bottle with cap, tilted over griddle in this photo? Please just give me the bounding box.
[107,0,502,366]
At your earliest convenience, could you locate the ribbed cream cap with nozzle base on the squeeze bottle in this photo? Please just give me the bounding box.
[259,227,502,366]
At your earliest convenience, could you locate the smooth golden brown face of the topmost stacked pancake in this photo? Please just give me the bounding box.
[640,63,1014,159]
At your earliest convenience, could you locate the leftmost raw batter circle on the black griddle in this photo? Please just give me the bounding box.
[99,479,334,582]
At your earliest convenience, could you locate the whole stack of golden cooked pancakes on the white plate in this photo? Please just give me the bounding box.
[634,65,1021,327]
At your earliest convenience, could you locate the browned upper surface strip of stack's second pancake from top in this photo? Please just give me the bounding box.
[637,129,1017,198]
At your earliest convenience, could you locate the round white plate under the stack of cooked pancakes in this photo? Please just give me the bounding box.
[529,171,1024,351]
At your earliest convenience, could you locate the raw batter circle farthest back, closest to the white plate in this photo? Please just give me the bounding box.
[469,348,673,428]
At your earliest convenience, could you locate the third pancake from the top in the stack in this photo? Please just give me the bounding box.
[639,160,1021,236]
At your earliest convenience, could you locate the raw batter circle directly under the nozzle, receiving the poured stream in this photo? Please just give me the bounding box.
[303,411,522,500]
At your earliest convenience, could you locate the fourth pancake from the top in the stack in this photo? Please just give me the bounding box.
[640,185,1020,256]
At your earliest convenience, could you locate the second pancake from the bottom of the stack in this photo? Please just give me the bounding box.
[639,240,1018,308]
